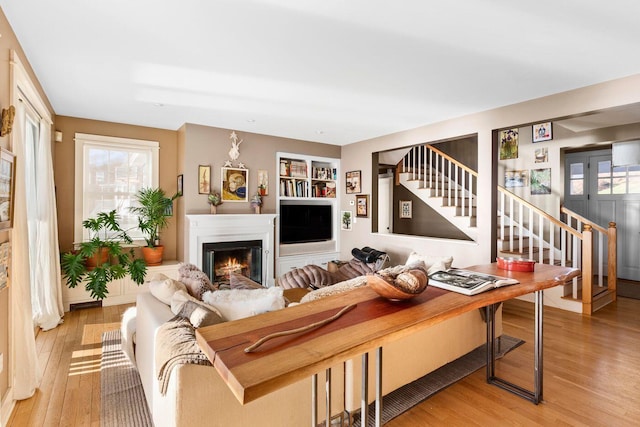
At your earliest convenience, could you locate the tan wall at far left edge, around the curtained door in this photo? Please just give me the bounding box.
[0,9,53,412]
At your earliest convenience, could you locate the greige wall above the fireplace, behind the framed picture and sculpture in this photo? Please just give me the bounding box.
[178,124,341,259]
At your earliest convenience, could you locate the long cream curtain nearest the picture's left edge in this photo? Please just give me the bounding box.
[11,98,42,400]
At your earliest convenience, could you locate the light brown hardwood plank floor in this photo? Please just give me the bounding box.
[8,298,640,427]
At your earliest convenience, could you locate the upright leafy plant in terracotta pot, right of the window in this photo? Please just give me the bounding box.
[129,187,178,265]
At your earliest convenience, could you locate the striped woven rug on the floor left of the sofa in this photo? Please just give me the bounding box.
[100,330,153,427]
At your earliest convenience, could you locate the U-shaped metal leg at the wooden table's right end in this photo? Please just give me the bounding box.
[485,291,544,405]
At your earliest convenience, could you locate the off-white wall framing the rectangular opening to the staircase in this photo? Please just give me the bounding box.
[341,75,640,266]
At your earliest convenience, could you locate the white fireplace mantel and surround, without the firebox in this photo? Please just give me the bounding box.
[184,214,276,286]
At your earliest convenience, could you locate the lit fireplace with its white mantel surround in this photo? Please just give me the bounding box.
[184,214,276,286]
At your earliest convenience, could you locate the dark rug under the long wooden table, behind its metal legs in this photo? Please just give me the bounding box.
[353,335,524,426]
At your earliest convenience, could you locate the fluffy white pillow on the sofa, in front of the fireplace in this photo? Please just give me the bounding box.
[202,287,284,320]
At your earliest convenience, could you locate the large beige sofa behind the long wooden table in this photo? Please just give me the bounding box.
[135,256,501,427]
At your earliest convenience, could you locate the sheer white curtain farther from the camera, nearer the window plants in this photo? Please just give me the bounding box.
[27,115,64,331]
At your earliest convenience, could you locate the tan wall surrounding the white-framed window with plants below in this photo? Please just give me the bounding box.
[54,116,178,259]
